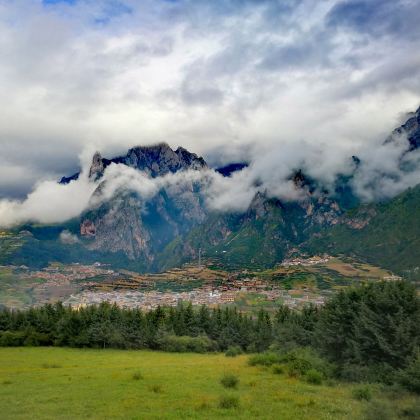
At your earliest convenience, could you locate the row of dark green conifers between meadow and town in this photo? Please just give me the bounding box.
[0,281,420,381]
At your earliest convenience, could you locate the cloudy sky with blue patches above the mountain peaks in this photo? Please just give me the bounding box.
[0,0,420,218]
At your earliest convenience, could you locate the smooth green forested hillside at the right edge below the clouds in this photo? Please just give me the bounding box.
[302,185,420,277]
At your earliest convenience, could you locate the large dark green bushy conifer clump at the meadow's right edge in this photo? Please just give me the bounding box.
[314,281,420,372]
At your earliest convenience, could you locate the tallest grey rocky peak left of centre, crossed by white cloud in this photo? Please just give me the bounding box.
[80,144,207,266]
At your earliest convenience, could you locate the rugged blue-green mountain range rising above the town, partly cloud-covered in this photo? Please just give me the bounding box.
[0,108,420,274]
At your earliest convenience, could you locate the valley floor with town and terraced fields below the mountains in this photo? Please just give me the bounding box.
[0,255,400,312]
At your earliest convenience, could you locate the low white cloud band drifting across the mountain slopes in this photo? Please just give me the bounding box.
[0,127,420,228]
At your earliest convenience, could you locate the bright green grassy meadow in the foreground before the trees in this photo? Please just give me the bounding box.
[0,348,416,420]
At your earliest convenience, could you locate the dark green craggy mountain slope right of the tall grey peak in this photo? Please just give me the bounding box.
[158,185,343,268]
